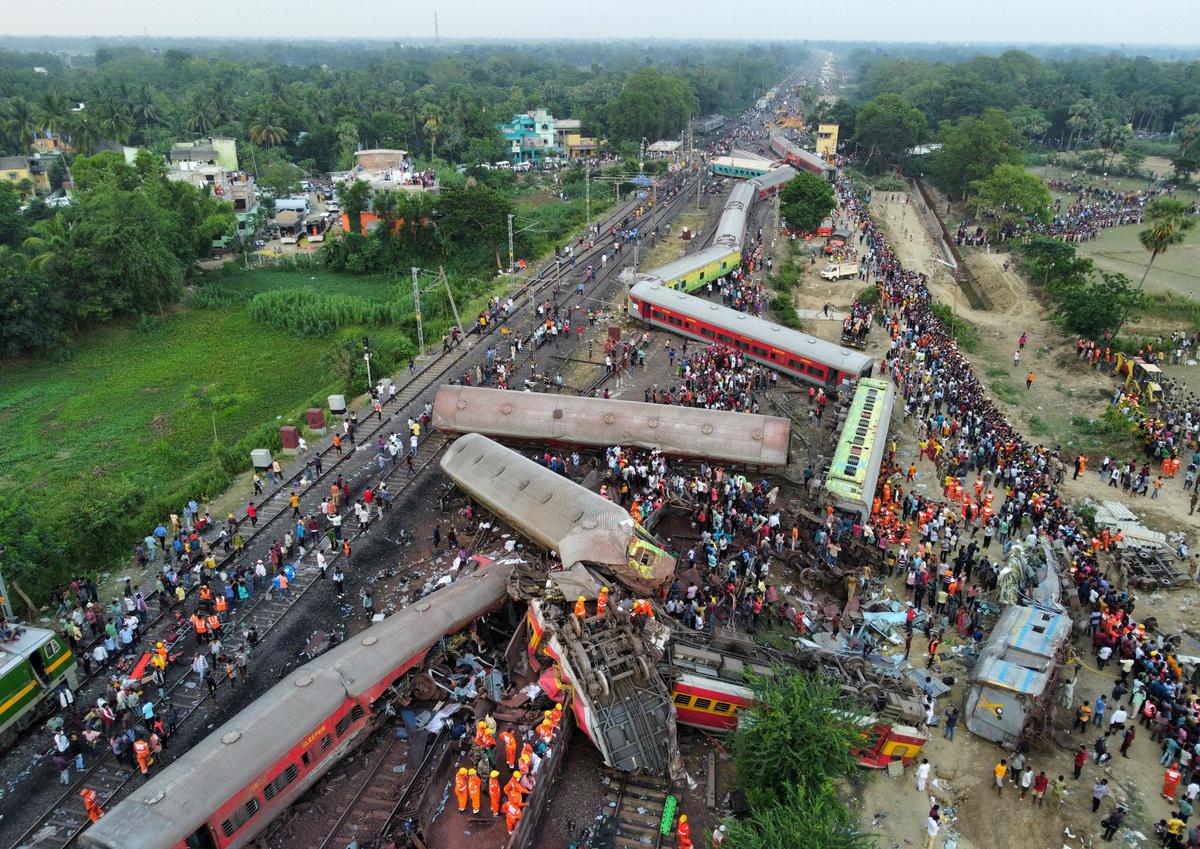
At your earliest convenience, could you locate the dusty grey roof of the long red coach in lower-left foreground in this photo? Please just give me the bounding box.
[83,564,511,849]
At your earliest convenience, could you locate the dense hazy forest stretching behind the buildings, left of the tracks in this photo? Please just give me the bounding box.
[0,43,806,171]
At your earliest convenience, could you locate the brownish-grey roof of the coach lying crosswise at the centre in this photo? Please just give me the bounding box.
[433,386,791,466]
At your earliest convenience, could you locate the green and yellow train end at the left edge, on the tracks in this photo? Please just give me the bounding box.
[0,626,78,747]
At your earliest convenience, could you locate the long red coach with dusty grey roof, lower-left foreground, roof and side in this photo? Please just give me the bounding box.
[80,564,512,849]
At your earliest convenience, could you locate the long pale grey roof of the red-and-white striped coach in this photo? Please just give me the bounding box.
[629,282,875,374]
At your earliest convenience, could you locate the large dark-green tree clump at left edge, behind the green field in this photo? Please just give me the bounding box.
[0,152,234,356]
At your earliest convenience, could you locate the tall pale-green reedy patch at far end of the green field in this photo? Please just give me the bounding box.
[250,289,413,336]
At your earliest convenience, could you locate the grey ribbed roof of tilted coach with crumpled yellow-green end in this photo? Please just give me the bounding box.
[442,433,673,584]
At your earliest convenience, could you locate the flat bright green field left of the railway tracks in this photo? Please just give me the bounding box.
[0,270,427,594]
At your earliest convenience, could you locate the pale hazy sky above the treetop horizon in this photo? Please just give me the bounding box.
[7,0,1200,46]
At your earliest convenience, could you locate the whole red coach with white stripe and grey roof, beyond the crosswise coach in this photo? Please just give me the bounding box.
[629,282,875,389]
